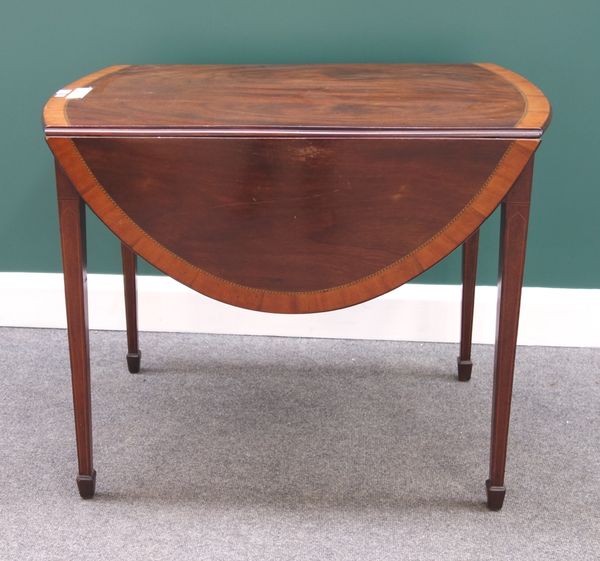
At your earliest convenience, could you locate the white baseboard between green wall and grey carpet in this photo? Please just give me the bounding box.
[0,273,600,347]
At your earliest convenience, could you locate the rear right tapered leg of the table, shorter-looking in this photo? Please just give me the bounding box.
[457,230,479,382]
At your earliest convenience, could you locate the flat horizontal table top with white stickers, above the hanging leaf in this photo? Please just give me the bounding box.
[44,64,550,138]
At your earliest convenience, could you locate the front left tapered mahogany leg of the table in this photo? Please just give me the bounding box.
[56,164,96,499]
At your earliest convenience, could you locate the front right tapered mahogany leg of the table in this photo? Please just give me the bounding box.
[486,159,533,510]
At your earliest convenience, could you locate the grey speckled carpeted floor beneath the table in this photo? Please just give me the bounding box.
[0,329,600,561]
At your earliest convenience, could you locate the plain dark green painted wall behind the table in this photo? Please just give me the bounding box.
[0,0,600,288]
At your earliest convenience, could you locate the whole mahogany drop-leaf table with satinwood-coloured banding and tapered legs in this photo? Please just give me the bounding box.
[44,64,550,510]
